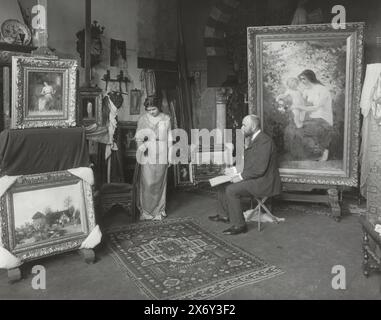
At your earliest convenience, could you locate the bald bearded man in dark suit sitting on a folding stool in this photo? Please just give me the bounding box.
[209,115,281,235]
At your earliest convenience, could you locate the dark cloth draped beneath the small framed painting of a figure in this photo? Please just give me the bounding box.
[0,128,90,176]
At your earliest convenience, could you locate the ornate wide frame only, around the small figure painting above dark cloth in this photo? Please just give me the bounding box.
[11,56,77,129]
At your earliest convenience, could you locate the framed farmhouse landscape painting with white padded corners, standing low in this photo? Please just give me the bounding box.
[0,171,95,261]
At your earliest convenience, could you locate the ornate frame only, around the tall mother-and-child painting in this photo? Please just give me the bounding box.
[247,22,364,186]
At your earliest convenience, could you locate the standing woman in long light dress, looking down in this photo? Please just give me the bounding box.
[136,96,171,220]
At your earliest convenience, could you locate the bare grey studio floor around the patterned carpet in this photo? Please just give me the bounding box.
[0,192,381,300]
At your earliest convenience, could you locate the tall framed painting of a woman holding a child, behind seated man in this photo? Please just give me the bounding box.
[248,23,364,186]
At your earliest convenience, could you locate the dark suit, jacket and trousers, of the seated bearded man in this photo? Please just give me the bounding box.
[219,132,281,227]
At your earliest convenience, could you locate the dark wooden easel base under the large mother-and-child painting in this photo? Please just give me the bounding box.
[279,183,342,221]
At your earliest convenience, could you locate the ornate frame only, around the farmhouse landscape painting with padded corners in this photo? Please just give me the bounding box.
[0,171,95,261]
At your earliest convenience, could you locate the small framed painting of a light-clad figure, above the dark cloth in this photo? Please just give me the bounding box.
[11,56,77,129]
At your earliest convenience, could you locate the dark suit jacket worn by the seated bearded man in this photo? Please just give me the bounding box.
[241,132,281,197]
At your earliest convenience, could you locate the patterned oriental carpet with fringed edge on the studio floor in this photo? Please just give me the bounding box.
[108,219,283,300]
